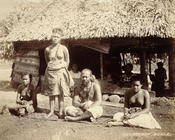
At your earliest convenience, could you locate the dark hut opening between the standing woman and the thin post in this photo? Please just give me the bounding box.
[69,45,100,78]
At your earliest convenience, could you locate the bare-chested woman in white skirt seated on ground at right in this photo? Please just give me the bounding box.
[108,77,161,129]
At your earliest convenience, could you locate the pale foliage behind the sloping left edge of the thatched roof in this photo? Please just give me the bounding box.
[0,1,48,38]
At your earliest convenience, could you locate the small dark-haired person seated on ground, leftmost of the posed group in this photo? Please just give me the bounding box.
[9,74,34,116]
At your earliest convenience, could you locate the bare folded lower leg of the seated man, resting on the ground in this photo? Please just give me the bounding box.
[65,111,92,121]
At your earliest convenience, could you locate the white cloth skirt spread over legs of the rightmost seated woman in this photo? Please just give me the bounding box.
[113,112,161,129]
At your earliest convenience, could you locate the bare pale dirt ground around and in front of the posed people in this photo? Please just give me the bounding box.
[0,62,175,140]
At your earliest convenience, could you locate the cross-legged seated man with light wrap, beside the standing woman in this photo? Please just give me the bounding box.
[65,69,103,122]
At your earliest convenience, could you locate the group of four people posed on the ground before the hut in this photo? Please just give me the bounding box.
[8,29,161,129]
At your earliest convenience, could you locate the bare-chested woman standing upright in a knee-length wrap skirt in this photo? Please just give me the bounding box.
[44,29,73,118]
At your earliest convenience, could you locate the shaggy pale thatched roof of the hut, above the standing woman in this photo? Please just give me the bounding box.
[7,0,175,41]
